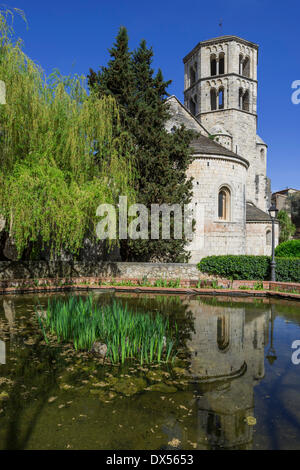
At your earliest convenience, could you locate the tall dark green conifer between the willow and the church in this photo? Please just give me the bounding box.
[89,27,193,262]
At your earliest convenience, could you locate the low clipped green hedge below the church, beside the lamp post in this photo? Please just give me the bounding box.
[197,255,300,282]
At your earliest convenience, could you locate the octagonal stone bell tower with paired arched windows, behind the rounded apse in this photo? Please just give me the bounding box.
[183,36,269,211]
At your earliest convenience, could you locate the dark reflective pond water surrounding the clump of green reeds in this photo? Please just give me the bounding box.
[0,291,300,450]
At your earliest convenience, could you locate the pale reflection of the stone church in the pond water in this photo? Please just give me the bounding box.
[188,300,267,449]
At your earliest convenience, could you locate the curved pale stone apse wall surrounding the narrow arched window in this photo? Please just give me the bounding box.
[187,155,247,263]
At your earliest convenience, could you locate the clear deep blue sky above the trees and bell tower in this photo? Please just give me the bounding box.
[7,0,300,191]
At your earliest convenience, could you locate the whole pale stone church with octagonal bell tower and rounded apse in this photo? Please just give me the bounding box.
[167,36,278,263]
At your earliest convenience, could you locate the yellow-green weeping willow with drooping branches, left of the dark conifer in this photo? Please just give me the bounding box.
[0,11,134,256]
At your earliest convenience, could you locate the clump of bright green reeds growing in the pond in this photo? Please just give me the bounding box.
[36,296,178,364]
